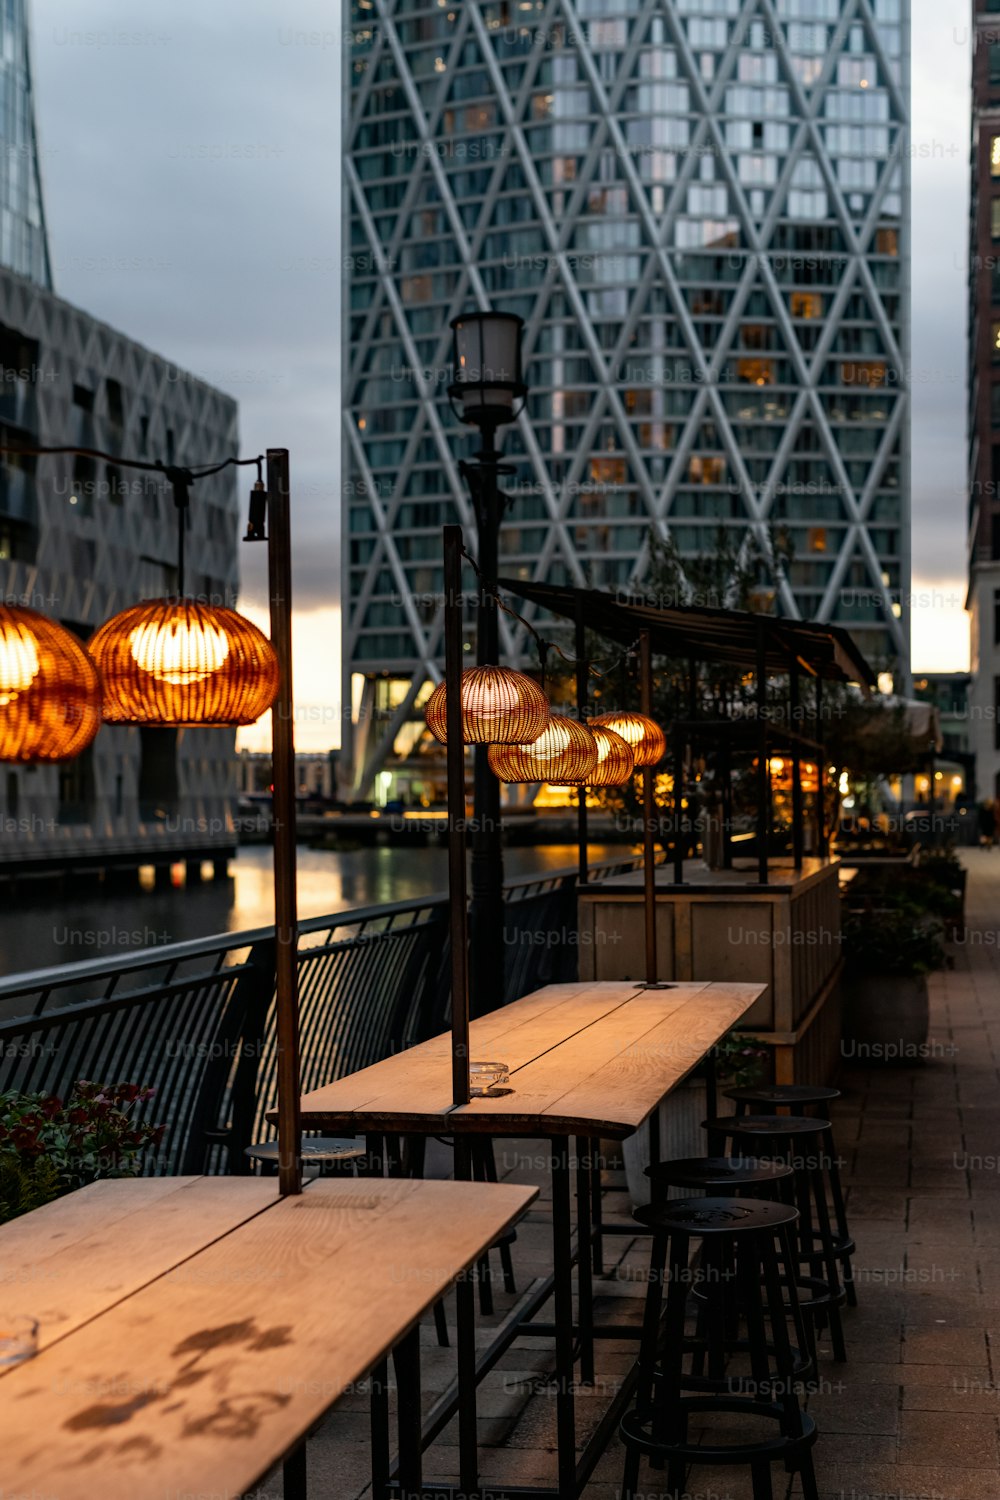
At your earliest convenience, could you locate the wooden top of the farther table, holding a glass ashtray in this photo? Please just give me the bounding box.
[289,980,765,1137]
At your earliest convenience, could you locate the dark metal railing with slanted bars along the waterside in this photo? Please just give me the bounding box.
[0,857,640,1175]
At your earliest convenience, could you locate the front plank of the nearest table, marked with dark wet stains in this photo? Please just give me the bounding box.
[0,1178,535,1500]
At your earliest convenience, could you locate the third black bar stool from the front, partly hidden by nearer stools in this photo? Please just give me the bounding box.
[702,1115,847,1364]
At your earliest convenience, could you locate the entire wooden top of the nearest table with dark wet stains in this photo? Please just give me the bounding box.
[0,1178,537,1500]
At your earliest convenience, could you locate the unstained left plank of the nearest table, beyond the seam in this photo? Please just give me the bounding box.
[0,1178,277,1368]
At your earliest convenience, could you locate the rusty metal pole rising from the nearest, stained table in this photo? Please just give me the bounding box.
[267,449,301,1197]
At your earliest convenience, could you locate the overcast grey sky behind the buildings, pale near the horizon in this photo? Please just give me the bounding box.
[33,0,970,747]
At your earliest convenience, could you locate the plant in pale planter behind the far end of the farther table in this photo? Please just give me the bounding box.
[622,1031,771,1208]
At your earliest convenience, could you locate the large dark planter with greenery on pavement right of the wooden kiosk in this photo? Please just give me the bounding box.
[843,902,946,1064]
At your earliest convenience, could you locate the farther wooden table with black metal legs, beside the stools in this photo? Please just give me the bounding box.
[284,980,763,1500]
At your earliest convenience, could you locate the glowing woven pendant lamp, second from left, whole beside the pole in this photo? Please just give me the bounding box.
[90,599,279,725]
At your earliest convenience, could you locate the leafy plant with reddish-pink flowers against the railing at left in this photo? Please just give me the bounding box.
[0,1080,165,1224]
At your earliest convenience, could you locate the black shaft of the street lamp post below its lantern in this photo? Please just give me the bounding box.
[463,428,505,1016]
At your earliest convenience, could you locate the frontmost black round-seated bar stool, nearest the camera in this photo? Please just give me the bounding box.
[621,1197,817,1500]
